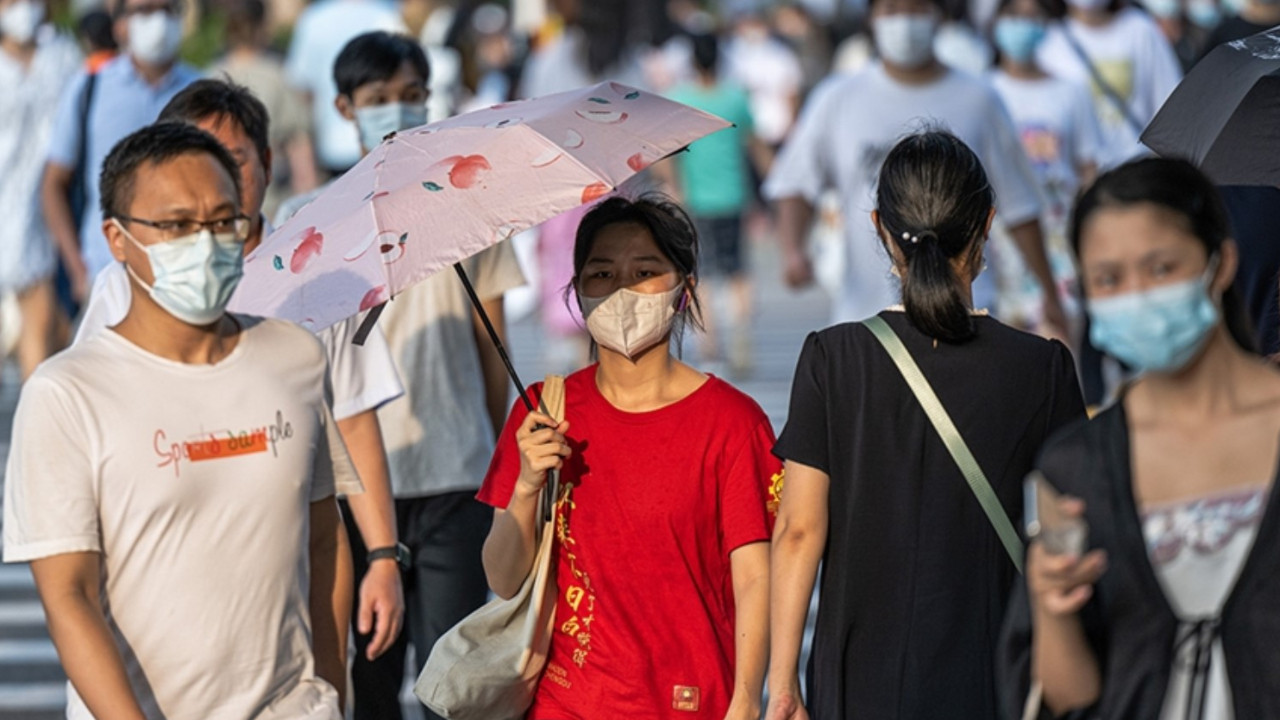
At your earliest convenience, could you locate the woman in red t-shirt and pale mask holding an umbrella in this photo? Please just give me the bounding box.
[479,197,782,720]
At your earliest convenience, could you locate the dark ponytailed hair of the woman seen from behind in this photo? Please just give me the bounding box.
[876,131,996,342]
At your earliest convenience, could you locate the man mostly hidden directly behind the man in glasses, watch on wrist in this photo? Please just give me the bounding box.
[76,79,404,657]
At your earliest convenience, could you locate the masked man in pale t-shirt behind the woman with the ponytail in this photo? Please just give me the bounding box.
[764,0,1066,337]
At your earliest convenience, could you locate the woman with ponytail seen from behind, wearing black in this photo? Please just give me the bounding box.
[767,132,1084,720]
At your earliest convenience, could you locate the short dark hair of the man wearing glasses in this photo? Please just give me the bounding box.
[99,123,239,218]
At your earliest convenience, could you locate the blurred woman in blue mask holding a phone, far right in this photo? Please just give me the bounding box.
[1001,159,1280,720]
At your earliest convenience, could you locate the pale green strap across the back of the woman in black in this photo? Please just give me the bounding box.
[863,316,1023,573]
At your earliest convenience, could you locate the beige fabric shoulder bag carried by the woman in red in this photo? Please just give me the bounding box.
[413,375,564,720]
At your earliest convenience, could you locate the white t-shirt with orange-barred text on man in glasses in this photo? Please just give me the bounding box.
[4,315,361,720]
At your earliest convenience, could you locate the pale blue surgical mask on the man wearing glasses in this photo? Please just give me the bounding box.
[114,220,244,325]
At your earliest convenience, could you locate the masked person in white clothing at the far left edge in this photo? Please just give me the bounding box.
[0,0,81,378]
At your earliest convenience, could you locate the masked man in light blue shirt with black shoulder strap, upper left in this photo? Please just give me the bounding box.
[41,0,200,302]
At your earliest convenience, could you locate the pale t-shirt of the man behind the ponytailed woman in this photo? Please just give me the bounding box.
[764,63,1041,323]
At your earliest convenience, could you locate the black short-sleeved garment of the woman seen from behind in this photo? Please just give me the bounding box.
[774,310,1084,720]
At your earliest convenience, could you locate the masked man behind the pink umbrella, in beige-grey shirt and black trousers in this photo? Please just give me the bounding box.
[276,32,525,720]
